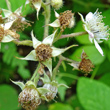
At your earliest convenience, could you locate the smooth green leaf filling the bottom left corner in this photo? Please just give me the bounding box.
[0,84,20,110]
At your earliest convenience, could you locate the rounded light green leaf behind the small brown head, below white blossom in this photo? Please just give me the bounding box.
[70,45,106,65]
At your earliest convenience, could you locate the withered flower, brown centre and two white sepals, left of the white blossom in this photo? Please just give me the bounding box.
[48,10,75,31]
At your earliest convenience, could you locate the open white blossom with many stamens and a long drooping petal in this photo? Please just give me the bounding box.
[79,10,109,56]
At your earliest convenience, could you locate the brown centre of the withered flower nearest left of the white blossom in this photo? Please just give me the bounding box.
[59,10,74,31]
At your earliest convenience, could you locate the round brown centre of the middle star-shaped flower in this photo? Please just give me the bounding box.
[35,44,52,61]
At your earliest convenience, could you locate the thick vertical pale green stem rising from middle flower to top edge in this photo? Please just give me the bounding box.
[42,0,51,38]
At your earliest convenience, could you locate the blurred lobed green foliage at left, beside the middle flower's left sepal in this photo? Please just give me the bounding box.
[1,43,30,79]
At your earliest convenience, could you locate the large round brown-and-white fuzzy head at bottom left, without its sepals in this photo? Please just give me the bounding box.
[18,87,41,110]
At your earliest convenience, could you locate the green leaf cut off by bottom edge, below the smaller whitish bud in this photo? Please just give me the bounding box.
[49,103,73,110]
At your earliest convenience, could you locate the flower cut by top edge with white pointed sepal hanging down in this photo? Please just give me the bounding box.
[25,0,42,18]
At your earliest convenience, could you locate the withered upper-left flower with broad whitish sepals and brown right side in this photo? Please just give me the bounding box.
[2,6,31,32]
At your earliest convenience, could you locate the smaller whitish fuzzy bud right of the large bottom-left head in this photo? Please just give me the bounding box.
[43,84,58,101]
